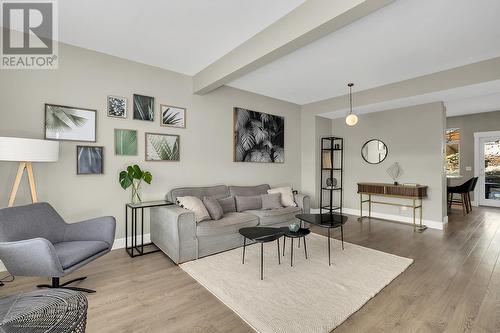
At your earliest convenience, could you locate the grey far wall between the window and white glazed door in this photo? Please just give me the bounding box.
[446,111,500,198]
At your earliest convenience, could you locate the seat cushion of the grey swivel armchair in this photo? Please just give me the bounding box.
[54,241,109,269]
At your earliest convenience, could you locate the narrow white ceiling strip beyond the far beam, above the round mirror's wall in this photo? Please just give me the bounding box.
[320,80,500,120]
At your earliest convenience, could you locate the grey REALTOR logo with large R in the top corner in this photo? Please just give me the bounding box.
[0,0,58,69]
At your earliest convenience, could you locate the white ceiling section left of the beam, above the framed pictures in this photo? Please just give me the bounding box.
[58,0,305,75]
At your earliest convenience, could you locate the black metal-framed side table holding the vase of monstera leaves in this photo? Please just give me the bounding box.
[125,200,174,258]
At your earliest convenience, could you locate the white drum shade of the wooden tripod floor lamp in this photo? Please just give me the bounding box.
[0,136,59,162]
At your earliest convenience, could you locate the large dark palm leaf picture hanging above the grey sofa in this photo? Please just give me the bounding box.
[234,108,285,163]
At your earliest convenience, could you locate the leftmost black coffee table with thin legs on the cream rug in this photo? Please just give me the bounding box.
[239,227,283,280]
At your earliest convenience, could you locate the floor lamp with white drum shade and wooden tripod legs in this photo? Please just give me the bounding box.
[0,137,59,207]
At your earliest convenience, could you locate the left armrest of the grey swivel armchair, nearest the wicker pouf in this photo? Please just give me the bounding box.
[0,238,63,277]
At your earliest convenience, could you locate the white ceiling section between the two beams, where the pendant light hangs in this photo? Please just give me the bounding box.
[229,0,500,104]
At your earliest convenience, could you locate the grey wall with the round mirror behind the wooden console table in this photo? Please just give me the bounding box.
[332,103,446,223]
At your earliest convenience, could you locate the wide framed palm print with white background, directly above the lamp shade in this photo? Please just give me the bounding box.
[45,104,97,142]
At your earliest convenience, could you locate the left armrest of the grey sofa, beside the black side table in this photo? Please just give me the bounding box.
[151,205,198,264]
